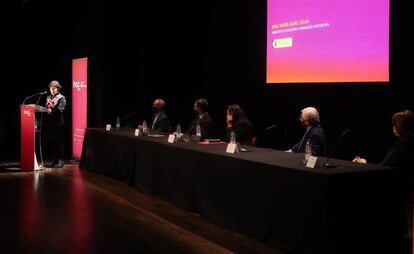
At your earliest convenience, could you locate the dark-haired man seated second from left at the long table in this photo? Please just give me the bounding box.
[186,99,214,139]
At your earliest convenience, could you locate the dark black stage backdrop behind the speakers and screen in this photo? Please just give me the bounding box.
[0,0,413,162]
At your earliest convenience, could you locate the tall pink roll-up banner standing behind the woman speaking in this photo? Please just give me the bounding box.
[72,58,88,159]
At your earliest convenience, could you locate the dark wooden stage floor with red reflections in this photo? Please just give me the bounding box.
[0,162,283,254]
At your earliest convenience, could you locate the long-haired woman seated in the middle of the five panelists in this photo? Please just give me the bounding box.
[226,104,253,145]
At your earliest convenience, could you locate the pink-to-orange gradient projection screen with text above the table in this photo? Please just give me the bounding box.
[266,0,390,83]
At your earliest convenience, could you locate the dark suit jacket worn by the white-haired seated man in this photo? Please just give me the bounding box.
[291,124,326,156]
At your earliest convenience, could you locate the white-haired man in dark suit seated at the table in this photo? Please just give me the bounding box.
[288,107,326,156]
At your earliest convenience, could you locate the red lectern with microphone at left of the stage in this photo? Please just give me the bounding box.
[20,104,47,171]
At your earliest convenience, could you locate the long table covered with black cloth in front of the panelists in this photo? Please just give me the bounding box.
[80,128,403,253]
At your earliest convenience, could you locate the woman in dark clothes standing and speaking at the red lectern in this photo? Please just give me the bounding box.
[45,80,66,168]
